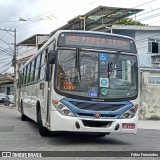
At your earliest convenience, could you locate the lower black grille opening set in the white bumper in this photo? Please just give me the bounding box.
[82,120,112,128]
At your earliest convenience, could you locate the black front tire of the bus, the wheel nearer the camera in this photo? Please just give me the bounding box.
[37,109,50,137]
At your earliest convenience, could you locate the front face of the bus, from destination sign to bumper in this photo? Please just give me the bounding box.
[50,31,139,135]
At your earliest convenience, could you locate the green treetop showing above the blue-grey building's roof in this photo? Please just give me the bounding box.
[114,18,147,26]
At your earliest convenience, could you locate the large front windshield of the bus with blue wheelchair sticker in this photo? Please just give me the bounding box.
[56,50,138,99]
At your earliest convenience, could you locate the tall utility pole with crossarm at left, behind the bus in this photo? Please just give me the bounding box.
[0,28,17,107]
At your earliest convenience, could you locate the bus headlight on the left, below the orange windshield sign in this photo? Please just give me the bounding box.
[54,103,74,117]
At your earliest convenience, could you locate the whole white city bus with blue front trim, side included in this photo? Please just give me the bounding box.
[18,30,139,136]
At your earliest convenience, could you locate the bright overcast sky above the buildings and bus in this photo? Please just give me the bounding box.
[0,0,160,73]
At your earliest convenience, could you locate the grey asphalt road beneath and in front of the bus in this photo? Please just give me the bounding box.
[0,106,160,159]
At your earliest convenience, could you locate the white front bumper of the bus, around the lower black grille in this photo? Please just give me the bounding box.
[50,111,138,134]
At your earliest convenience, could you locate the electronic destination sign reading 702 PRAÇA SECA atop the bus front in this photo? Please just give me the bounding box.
[58,33,136,53]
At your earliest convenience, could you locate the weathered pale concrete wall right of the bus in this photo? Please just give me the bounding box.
[140,71,160,120]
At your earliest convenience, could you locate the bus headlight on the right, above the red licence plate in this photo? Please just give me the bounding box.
[119,105,138,119]
